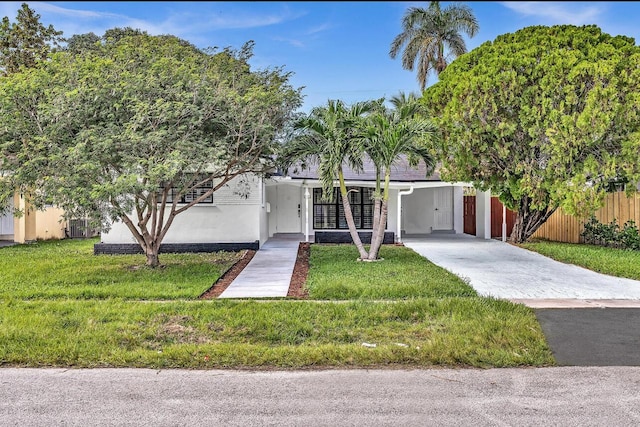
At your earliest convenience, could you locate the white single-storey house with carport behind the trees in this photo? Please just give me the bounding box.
[95,162,491,253]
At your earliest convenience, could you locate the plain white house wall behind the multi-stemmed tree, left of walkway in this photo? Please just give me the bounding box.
[101,176,266,244]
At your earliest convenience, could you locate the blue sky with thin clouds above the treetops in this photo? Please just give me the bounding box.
[0,1,640,111]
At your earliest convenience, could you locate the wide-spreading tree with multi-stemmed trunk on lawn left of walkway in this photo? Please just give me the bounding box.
[0,31,301,266]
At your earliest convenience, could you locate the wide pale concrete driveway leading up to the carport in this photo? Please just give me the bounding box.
[403,234,640,307]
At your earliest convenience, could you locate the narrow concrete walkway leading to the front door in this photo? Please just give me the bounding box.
[218,234,301,298]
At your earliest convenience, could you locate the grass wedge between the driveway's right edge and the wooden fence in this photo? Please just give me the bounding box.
[521,242,640,280]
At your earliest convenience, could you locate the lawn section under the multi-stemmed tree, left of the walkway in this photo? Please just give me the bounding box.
[0,239,239,300]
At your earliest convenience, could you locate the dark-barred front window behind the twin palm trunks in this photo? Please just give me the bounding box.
[313,187,374,230]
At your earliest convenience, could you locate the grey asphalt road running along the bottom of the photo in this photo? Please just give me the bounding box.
[0,367,640,427]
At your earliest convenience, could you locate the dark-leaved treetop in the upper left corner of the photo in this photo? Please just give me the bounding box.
[0,3,64,75]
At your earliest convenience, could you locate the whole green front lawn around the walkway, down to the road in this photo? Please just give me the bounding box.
[0,239,555,369]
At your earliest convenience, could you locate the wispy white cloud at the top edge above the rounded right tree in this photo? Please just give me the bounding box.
[500,1,606,25]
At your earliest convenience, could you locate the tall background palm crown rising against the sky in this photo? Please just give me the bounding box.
[389,1,479,90]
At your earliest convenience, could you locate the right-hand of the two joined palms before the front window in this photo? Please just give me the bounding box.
[361,93,437,260]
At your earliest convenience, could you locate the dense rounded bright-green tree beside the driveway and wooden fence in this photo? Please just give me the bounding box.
[424,25,640,242]
